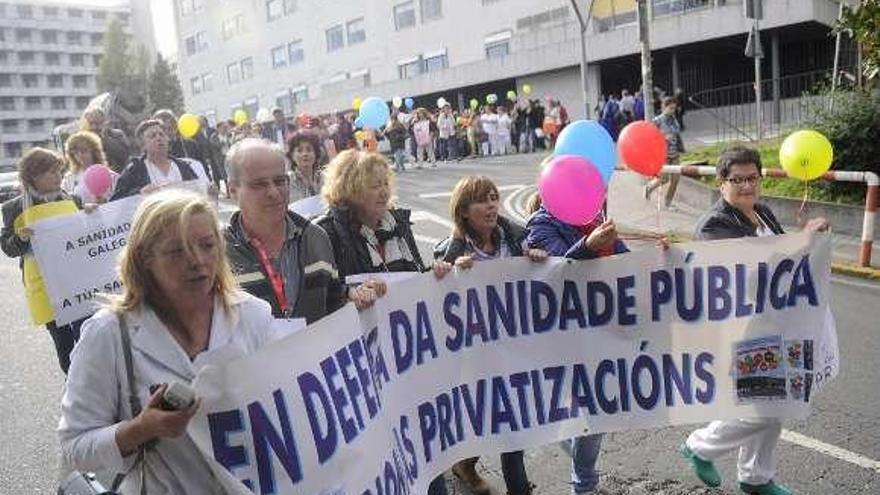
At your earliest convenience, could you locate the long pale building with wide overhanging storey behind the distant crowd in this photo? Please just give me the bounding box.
[175,0,838,128]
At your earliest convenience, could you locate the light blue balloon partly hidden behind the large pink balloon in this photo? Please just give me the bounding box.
[553,120,617,186]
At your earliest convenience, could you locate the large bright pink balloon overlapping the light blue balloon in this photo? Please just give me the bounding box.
[538,155,605,225]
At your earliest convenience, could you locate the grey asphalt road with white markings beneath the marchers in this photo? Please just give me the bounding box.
[0,155,880,495]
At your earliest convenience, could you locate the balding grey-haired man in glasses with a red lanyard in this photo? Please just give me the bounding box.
[226,138,385,323]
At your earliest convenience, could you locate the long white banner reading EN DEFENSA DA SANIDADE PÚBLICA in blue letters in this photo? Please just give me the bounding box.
[189,234,838,495]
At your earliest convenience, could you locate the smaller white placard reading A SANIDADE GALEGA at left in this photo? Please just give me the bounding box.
[31,196,141,325]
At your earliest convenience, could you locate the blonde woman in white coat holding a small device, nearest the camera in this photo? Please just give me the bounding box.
[58,190,280,494]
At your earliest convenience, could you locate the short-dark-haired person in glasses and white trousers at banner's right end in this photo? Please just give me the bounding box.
[680,146,828,495]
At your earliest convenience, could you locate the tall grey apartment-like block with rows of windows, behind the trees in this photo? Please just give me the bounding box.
[0,0,154,168]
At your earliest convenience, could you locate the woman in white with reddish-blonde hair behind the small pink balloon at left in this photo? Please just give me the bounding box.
[61,131,119,203]
